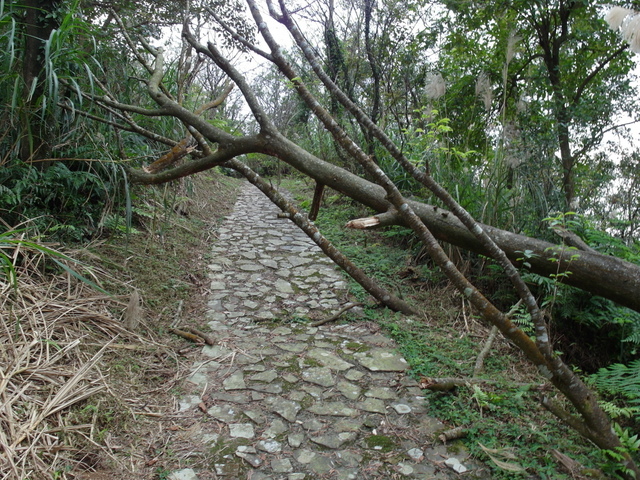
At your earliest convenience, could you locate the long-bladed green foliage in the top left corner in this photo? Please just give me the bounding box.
[0,0,94,161]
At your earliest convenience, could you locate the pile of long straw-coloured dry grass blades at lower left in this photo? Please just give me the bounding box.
[0,246,175,479]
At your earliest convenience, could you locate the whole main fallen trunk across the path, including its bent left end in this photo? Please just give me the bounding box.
[129,129,640,312]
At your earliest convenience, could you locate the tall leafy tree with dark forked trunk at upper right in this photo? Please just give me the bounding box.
[432,0,637,214]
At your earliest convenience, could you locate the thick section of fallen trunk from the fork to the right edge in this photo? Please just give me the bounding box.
[258,133,640,312]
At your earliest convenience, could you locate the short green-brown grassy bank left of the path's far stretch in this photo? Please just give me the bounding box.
[92,173,238,324]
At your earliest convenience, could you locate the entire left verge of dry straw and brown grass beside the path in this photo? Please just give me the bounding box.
[0,171,238,480]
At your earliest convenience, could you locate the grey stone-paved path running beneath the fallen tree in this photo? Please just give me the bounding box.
[169,184,473,480]
